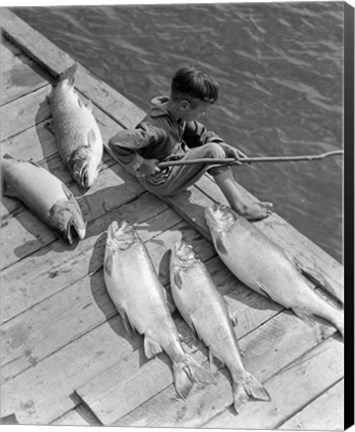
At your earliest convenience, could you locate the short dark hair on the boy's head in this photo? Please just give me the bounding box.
[171,66,219,108]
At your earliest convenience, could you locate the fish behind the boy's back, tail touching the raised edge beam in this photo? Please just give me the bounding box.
[48,63,103,190]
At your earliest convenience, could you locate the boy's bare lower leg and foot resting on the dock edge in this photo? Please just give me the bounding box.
[211,168,273,221]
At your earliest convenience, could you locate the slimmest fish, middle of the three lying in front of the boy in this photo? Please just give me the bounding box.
[170,240,271,413]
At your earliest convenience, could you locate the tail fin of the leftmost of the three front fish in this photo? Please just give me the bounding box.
[173,354,214,399]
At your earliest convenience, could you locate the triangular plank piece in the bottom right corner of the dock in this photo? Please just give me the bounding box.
[279,379,344,431]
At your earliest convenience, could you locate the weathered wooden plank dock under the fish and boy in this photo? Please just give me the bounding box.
[1,9,344,430]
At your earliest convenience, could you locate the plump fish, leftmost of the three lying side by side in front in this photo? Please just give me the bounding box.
[104,220,212,399]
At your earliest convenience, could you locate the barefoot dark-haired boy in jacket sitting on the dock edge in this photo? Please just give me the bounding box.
[109,67,272,220]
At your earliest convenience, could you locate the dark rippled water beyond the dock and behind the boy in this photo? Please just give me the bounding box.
[14,2,343,262]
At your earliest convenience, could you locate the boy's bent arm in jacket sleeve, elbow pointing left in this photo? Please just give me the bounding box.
[108,123,164,173]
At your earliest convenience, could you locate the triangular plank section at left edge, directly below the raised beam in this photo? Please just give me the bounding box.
[0,38,47,105]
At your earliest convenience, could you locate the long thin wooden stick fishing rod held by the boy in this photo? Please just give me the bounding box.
[157,150,344,168]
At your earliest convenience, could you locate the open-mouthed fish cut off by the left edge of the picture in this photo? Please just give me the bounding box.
[1,155,86,244]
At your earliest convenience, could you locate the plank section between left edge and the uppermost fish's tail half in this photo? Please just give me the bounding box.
[0,84,51,141]
